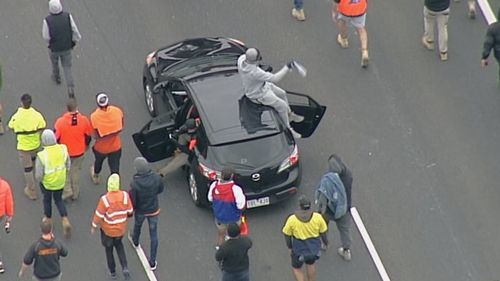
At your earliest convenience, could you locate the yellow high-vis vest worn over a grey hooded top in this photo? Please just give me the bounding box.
[37,144,69,191]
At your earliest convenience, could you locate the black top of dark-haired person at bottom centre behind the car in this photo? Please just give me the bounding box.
[215,237,252,272]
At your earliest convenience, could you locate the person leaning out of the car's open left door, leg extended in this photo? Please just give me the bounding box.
[159,118,197,177]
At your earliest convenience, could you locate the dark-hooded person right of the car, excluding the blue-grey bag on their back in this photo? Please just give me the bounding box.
[317,154,352,261]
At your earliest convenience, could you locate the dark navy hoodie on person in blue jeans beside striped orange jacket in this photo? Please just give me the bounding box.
[129,170,164,215]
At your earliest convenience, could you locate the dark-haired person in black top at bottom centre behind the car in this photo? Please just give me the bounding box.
[215,223,252,281]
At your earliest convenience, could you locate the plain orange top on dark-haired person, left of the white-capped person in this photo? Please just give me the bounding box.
[54,112,92,157]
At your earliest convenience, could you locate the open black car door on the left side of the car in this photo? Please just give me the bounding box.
[132,111,176,162]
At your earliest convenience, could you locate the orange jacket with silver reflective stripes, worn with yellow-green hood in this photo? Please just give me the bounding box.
[92,190,134,237]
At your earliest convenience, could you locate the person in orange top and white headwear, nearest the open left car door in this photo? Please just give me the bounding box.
[90,92,123,184]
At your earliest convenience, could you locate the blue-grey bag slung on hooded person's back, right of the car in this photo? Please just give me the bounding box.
[315,172,347,219]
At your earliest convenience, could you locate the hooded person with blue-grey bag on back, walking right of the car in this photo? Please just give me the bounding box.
[316,154,352,261]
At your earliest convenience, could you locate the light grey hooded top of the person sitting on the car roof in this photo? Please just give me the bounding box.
[238,55,290,100]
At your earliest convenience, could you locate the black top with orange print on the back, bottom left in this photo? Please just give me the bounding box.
[24,238,68,279]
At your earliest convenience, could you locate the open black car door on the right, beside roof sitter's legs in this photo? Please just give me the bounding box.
[286,92,326,138]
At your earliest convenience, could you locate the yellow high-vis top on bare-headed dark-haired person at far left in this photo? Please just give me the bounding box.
[8,107,47,151]
